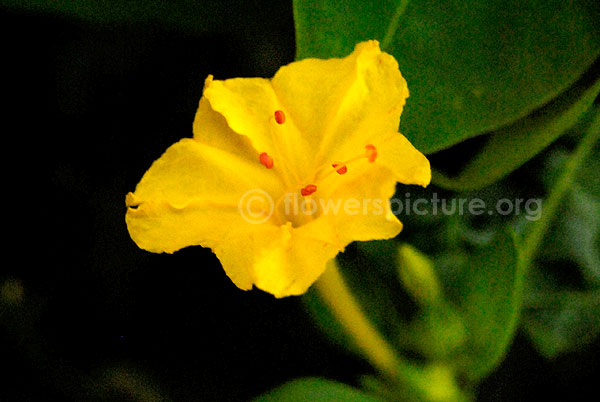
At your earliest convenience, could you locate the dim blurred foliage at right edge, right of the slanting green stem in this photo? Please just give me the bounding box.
[523,118,600,358]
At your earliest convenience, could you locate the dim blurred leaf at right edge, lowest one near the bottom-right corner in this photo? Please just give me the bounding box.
[523,291,600,358]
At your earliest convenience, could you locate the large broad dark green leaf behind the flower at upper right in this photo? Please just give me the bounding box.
[294,0,600,153]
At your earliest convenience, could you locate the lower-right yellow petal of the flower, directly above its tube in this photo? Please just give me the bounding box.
[246,166,402,297]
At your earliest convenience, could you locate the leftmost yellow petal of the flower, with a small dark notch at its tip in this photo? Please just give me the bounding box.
[126,138,283,253]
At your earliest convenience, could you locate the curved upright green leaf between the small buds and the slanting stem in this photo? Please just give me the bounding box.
[448,229,524,381]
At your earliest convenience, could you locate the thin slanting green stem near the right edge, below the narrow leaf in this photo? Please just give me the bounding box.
[520,113,600,267]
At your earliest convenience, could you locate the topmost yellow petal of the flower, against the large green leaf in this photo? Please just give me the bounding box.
[272,41,408,165]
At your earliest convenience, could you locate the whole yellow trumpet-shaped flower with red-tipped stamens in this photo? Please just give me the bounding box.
[126,41,431,297]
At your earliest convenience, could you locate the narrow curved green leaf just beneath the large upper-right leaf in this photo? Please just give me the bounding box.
[433,80,600,191]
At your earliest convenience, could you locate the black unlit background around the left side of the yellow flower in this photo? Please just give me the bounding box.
[0,1,600,402]
